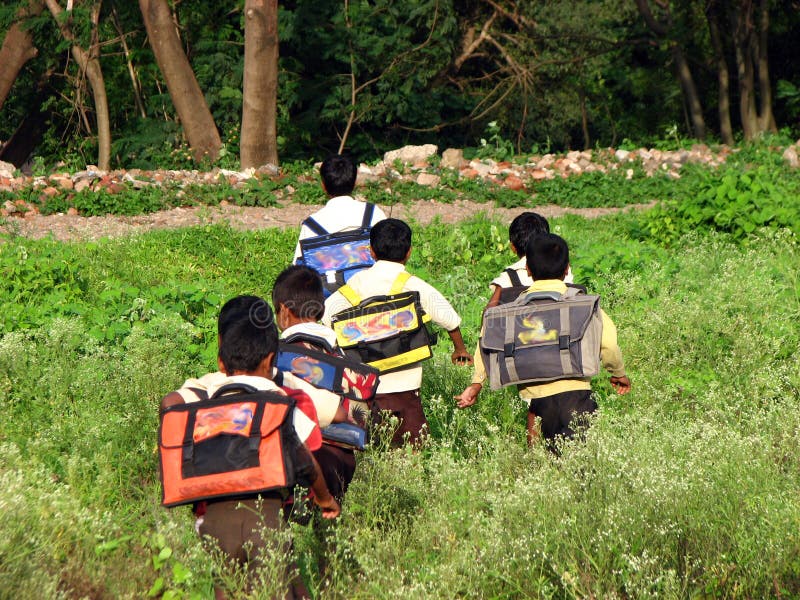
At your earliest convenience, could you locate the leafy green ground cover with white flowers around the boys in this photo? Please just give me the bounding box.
[0,190,800,598]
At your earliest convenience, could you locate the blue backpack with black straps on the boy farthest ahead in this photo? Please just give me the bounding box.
[300,203,375,298]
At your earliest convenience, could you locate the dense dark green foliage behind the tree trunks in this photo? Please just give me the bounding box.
[0,0,800,168]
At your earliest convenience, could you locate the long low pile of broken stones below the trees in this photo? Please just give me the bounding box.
[0,144,732,216]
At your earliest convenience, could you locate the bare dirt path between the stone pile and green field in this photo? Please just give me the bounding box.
[0,200,643,241]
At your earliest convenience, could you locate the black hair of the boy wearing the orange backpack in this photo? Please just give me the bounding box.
[217,296,278,373]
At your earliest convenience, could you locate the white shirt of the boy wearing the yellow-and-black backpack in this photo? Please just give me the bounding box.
[322,260,461,394]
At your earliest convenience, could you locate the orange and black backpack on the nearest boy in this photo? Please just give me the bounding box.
[158,383,312,507]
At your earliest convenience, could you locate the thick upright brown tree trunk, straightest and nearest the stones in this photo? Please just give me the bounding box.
[241,0,278,169]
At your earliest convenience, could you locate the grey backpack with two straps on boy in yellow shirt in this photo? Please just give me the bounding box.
[480,288,603,390]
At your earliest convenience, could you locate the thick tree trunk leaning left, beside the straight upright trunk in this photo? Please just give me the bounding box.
[139,0,222,161]
